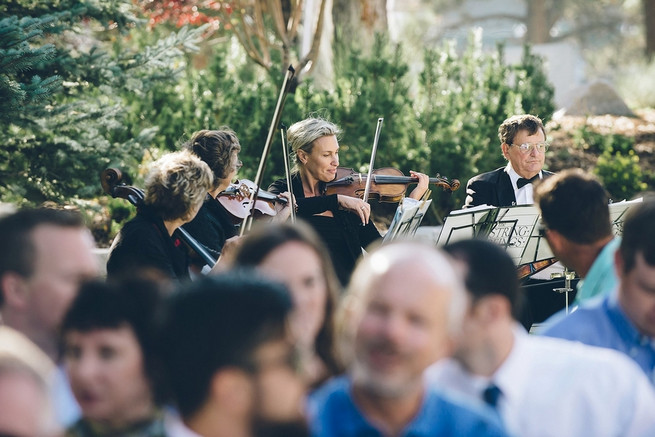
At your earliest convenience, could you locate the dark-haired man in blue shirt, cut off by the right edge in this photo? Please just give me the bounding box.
[543,199,655,383]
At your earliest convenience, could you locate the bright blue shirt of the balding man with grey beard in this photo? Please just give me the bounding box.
[309,376,507,437]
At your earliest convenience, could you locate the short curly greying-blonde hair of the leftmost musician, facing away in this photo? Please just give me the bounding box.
[144,150,214,220]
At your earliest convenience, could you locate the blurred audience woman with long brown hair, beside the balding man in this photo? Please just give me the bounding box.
[234,222,343,385]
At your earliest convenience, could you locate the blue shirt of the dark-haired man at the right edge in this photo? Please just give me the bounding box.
[541,290,655,384]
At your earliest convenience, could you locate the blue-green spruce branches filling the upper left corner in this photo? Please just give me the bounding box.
[0,0,204,203]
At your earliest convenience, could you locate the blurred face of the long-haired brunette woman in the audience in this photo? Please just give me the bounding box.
[259,241,328,346]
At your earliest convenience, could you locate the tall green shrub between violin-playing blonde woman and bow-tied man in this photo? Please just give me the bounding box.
[415,34,554,214]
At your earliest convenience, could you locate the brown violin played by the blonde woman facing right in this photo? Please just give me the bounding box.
[326,167,460,202]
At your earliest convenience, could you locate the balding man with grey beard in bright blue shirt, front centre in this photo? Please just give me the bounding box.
[309,243,506,437]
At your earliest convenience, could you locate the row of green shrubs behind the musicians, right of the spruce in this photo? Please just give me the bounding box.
[115,31,553,223]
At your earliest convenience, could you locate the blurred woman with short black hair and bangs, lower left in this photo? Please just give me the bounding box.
[61,279,165,437]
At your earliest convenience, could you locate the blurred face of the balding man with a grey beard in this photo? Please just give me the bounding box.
[353,268,451,398]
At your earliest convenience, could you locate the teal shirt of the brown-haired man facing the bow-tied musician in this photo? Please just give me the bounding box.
[575,237,621,304]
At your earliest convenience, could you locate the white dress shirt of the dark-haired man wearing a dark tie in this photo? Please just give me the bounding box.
[426,326,655,437]
